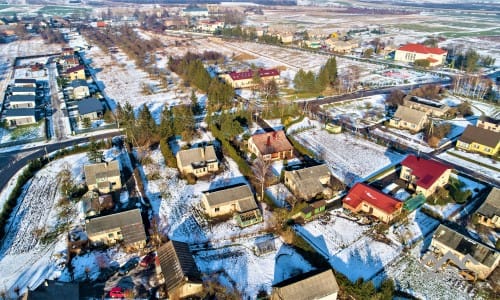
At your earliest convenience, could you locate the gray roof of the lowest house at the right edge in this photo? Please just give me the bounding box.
[432,224,499,267]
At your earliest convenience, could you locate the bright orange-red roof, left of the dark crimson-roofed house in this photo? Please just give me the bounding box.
[342,183,403,214]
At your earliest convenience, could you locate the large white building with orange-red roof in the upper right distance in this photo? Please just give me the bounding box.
[394,43,448,66]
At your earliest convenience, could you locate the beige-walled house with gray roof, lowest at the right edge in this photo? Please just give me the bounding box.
[430,224,500,279]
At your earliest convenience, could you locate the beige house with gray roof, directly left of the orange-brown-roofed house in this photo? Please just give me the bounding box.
[175,145,219,177]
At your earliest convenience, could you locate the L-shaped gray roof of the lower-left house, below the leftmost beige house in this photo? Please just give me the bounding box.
[85,208,146,244]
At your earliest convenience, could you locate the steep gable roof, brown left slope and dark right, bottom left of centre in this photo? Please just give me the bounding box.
[157,241,201,290]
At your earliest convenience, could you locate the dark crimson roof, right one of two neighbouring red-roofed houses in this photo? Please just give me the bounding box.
[401,155,451,189]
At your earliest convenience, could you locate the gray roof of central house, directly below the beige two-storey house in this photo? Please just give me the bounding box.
[203,184,257,212]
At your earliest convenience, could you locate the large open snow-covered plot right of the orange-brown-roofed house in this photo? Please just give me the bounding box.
[294,128,404,185]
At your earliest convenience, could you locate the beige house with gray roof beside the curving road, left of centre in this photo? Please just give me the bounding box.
[83,160,122,194]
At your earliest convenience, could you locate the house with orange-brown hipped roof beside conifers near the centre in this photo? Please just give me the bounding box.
[248,130,293,160]
